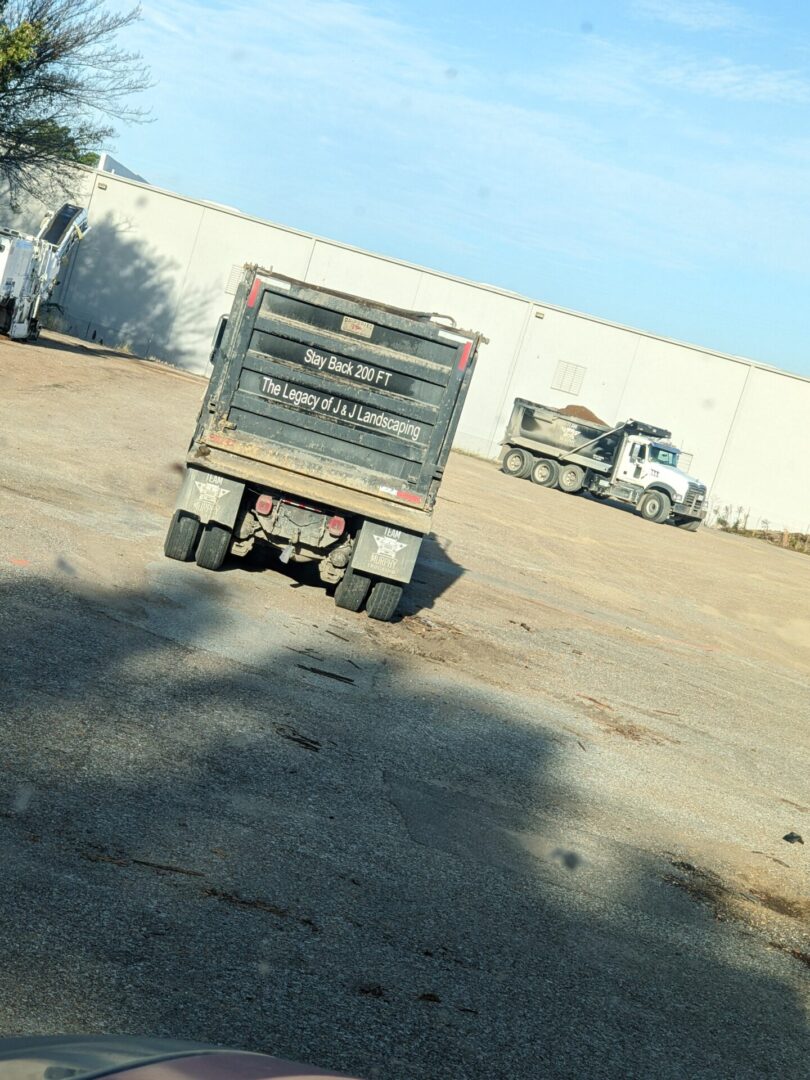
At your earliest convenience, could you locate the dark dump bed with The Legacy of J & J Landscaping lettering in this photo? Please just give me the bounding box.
[195,266,480,531]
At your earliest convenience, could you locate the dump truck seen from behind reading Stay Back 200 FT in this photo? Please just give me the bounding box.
[164,265,482,621]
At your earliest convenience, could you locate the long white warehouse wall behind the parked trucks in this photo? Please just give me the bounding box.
[5,170,810,531]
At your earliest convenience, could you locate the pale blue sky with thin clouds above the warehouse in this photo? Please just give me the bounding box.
[112,0,810,375]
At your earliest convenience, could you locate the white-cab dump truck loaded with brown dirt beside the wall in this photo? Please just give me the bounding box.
[500,397,707,532]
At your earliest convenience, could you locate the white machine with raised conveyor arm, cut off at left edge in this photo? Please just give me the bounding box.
[0,203,89,341]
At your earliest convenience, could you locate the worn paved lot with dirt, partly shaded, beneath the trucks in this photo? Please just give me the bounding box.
[0,336,810,1078]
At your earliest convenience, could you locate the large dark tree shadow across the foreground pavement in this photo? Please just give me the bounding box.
[0,567,810,1080]
